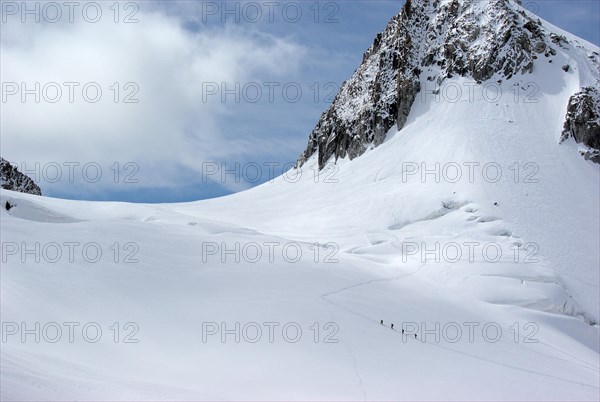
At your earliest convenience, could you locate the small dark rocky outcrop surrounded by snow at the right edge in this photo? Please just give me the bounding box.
[561,87,600,163]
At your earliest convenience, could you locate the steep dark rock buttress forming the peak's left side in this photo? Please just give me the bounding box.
[297,2,420,167]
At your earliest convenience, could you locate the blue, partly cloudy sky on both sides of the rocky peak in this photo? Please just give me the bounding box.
[0,0,600,203]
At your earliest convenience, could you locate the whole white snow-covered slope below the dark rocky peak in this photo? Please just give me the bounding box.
[0,0,600,400]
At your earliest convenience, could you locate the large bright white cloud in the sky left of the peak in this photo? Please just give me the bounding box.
[0,3,307,195]
